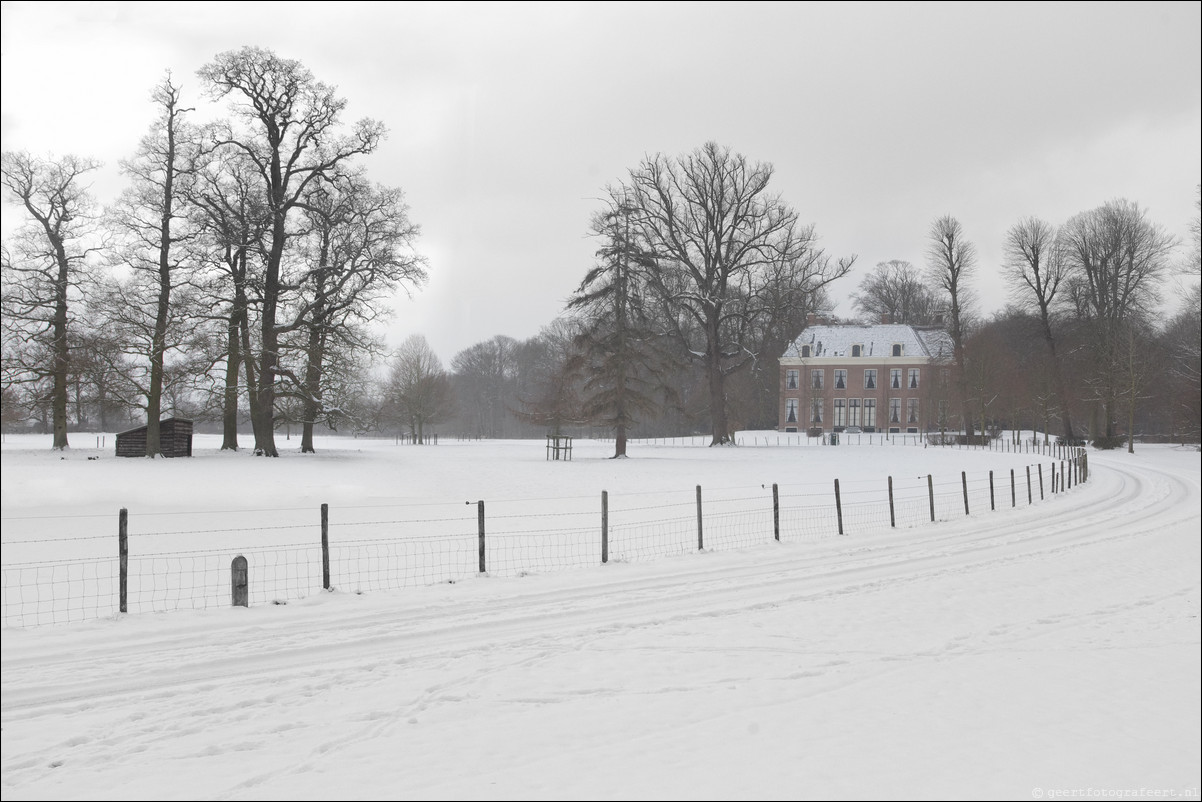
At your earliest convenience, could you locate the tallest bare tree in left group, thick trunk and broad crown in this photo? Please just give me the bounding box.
[197,47,385,457]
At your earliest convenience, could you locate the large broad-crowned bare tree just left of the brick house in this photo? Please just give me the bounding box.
[623,142,852,445]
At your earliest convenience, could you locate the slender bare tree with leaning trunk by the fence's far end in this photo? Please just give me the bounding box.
[1002,218,1073,442]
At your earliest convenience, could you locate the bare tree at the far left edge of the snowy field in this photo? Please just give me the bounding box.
[2,152,100,450]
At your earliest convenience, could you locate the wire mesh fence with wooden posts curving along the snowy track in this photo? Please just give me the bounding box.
[0,448,1088,628]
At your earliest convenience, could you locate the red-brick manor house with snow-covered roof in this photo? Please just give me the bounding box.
[778,315,956,436]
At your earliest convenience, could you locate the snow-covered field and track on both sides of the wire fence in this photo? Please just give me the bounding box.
[0,435,1202,800]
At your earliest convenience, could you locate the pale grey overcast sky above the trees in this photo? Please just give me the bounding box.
[0,2,1202,362]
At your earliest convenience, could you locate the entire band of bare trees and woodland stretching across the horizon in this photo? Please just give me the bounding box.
[2,47,1202,457]
